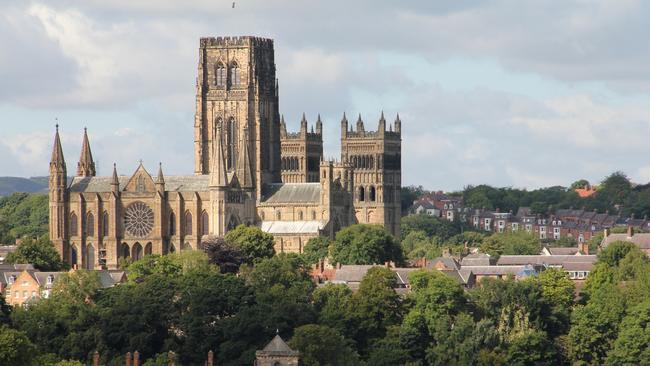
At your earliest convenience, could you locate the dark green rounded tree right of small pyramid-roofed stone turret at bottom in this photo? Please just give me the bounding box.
[289,324,359,366]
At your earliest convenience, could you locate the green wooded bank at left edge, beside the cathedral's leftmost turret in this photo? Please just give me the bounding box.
[0,193,48,244]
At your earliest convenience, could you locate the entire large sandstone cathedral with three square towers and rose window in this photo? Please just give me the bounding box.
[49,37,401,269]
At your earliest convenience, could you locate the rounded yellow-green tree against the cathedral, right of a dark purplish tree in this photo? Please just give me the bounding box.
[226,225,275,263]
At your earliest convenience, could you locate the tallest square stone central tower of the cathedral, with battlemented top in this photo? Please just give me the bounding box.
[194,37,281,197]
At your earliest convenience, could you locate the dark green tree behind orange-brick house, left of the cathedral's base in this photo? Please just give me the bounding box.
[6,236,66,271]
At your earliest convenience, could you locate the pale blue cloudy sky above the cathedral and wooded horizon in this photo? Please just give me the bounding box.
[0,0,650,191]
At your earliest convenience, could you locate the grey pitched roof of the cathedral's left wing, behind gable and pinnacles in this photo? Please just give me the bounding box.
[70,175,210,193]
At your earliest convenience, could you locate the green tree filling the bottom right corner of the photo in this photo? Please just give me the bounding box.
[607,300,650,366]
